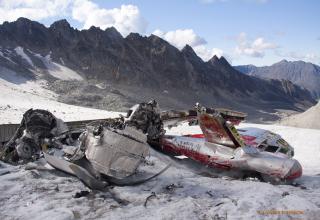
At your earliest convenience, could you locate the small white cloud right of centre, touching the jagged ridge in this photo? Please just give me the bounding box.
[153,29,224,61]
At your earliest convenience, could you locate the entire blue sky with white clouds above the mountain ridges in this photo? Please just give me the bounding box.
[0,0,320,66]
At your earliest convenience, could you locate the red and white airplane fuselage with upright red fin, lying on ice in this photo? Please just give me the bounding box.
[160,111,302,181]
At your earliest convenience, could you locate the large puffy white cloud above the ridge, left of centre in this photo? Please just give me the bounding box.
[72,0,147,36]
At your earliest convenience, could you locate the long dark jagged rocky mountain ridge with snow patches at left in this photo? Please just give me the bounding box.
[0,18,315,120]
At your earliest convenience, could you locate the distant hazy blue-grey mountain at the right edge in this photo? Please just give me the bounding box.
[235,60,320,98]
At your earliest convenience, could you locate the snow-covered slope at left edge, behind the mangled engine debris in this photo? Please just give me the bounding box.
[0,67,119,124]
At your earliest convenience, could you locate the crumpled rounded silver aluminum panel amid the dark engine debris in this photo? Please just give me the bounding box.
[85,126,149,178]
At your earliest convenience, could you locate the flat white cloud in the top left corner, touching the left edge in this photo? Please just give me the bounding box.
[0,0,72,23]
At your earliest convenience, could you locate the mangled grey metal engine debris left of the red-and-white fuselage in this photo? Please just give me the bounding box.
[1,101,170,190]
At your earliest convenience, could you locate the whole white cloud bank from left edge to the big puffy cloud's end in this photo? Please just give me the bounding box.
[0,0,147,36]
